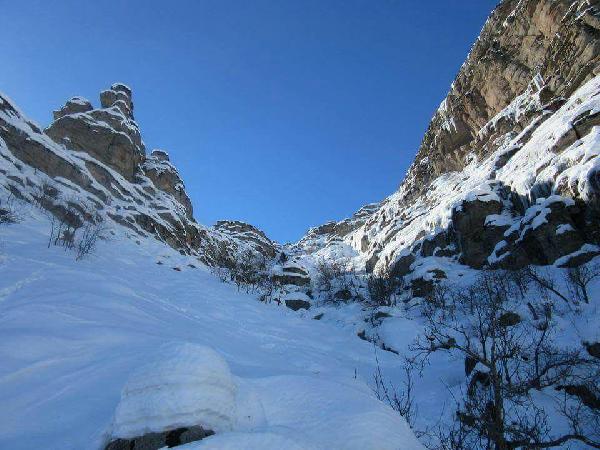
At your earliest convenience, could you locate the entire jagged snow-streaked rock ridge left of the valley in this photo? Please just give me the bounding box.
[0,83,278,264]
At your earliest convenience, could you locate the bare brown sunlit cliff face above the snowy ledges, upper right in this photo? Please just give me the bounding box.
[404,0,600,197]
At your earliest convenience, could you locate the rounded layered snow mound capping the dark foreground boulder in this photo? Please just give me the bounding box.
[113,343,237,438]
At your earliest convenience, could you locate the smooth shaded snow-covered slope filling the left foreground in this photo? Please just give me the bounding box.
[0,207,422,450]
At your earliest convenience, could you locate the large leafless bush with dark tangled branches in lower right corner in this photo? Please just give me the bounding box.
[414,271,600,450]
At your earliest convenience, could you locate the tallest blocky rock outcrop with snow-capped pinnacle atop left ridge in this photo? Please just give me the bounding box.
[45,83,145,181]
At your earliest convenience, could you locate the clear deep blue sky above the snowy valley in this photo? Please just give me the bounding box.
[0,0,496,242]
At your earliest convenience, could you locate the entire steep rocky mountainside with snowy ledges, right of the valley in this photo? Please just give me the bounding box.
[294,0,600,296]
